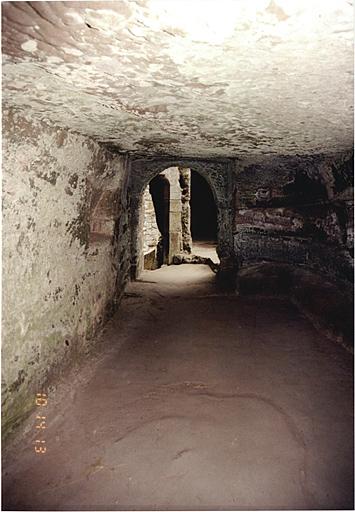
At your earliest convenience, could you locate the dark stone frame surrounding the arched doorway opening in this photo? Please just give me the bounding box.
[128,157,235,282]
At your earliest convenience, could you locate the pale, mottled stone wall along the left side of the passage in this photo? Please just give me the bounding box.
[2,110,130,436]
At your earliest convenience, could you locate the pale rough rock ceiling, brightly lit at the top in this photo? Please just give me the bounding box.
[2,0,353,158]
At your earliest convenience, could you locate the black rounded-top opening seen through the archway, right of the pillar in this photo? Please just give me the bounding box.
[190,170,217,242]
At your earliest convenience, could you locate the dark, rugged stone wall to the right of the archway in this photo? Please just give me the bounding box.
[234,154,353,288]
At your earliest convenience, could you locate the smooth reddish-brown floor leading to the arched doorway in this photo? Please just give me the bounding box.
[3,265,353,510]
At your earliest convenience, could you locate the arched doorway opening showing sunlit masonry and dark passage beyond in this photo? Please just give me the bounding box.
[142,167,219,270]
